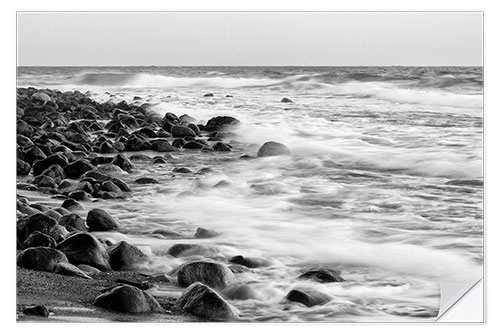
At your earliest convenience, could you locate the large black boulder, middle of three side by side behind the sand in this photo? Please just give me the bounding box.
[57,232,111,271]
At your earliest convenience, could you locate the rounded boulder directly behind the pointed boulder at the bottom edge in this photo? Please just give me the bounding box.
[177,261,235,288]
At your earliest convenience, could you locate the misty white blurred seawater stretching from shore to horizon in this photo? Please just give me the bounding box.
[18,67,483,321]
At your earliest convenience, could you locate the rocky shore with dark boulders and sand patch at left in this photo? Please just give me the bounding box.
[16,88,344,321]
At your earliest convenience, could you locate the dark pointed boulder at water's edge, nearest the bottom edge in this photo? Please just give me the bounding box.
[175,282,238,319]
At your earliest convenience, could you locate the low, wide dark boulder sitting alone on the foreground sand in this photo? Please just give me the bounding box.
[94,285,165,313]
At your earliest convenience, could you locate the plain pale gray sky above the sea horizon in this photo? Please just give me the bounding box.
[18,13,482,66]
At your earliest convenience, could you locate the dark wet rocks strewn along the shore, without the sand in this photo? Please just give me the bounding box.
[16,88,328,319]
